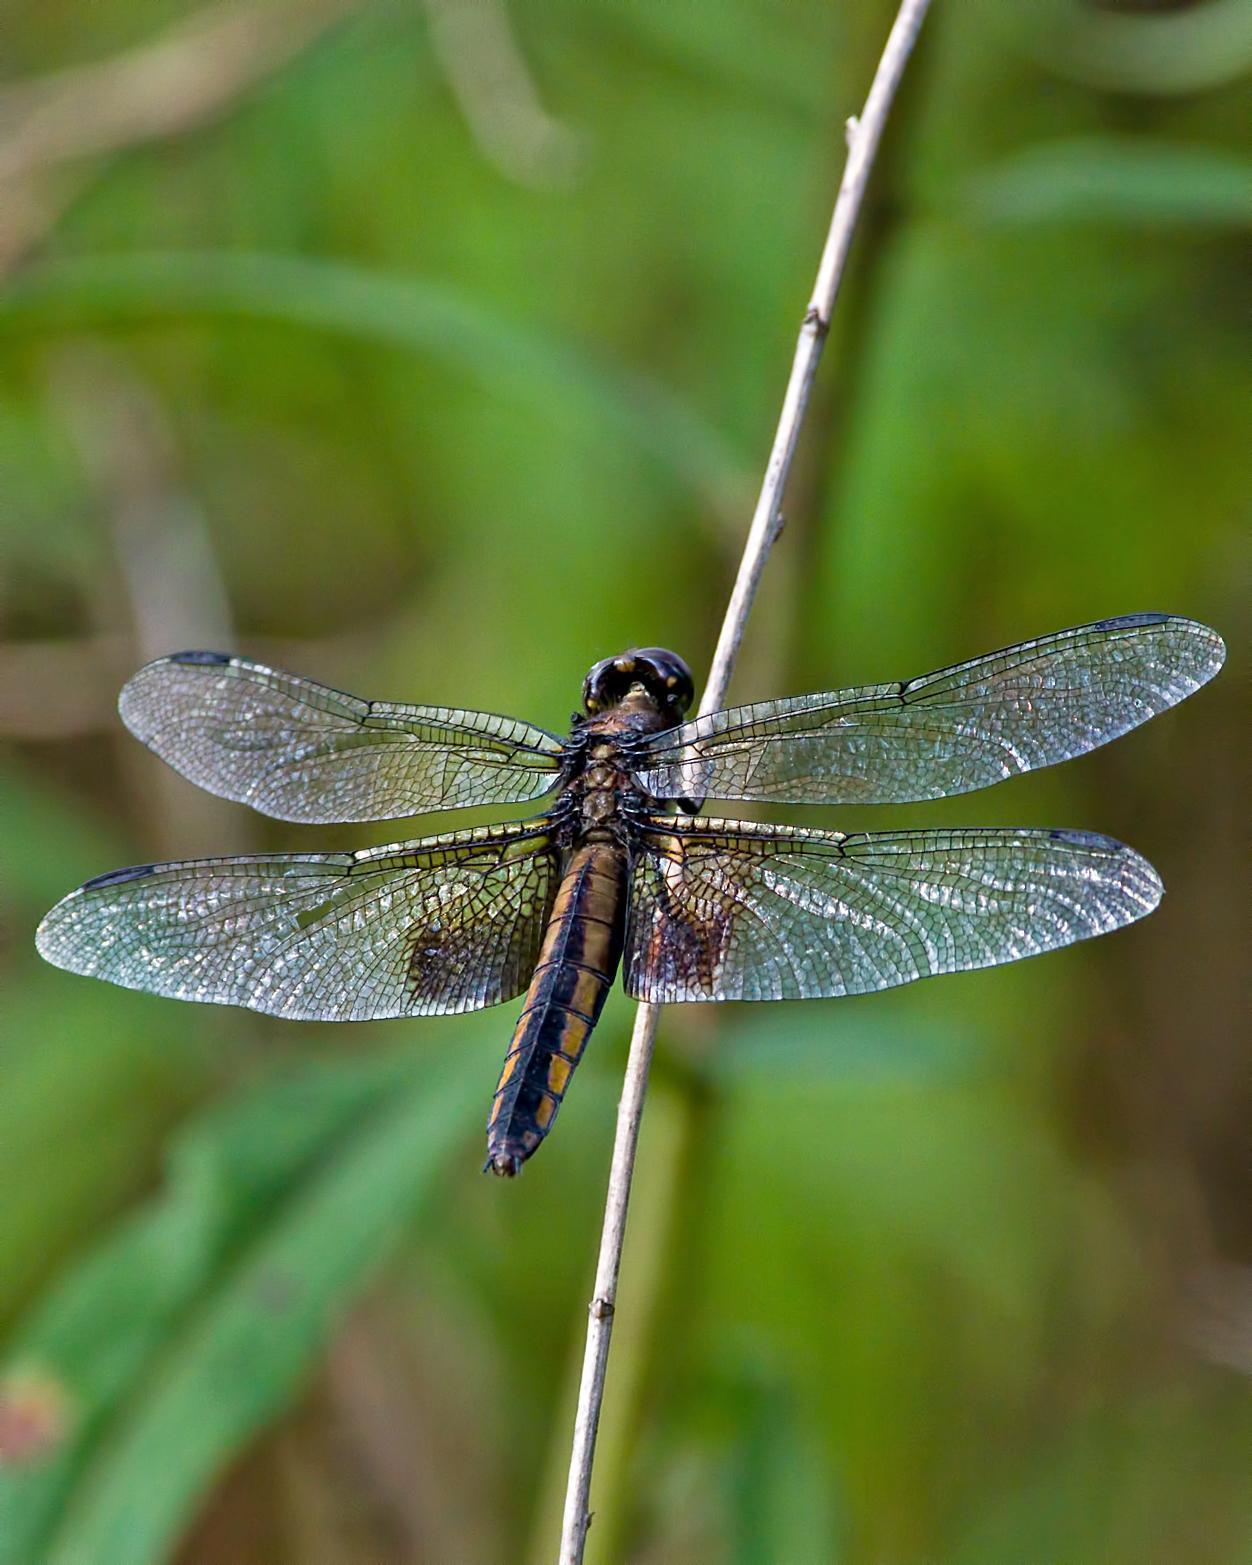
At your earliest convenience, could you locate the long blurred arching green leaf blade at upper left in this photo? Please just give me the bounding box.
[0,250,750,509]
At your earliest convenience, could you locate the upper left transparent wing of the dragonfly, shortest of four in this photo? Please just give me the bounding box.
[119,653,562,822]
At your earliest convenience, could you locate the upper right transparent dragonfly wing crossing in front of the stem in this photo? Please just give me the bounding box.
[637,613,1225,804]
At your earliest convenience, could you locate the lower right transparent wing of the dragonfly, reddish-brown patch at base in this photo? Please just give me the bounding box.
[624,817,1161,1003]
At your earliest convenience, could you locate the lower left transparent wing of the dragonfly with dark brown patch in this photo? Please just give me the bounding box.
[36,822,559,1022]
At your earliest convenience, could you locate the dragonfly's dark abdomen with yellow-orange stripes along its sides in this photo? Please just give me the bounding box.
[487,842,626,1175]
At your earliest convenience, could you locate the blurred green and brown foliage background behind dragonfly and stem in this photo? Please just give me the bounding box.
[0,0,1252,1565]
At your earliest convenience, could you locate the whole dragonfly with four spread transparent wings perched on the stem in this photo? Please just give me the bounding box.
[36,613,1225,1177]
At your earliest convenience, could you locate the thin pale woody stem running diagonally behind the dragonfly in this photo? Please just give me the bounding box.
[559,0,930,1565]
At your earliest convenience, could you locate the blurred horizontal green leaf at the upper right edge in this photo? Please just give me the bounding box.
[966,136,1252,228]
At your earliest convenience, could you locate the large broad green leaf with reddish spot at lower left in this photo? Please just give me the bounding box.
[0,1052,482,1565]
